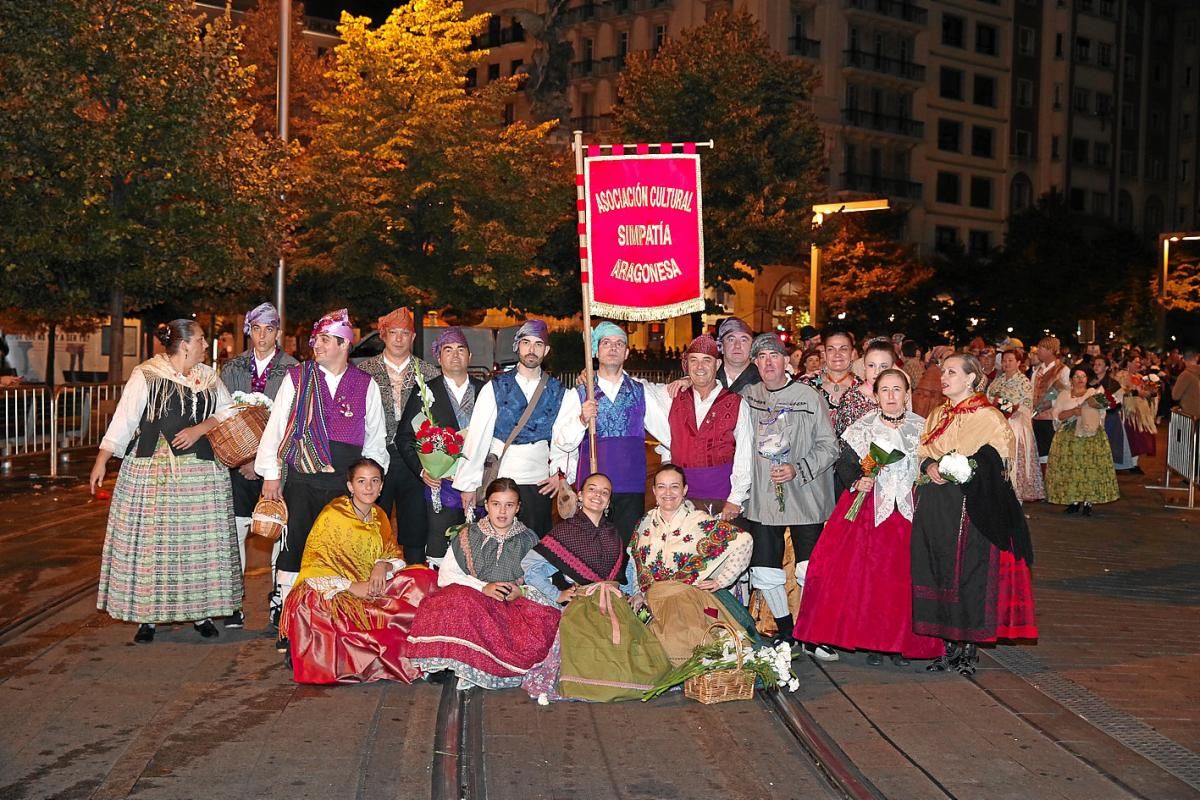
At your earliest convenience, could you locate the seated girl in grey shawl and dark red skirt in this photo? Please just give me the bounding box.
[408,477,559,688]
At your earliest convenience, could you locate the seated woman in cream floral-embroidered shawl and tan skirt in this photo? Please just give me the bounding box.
[630,464,754,664]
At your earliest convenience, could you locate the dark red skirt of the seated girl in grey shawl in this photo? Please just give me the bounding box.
[408,584,562,678]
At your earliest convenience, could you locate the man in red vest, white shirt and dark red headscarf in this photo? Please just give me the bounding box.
[647,333,754,519]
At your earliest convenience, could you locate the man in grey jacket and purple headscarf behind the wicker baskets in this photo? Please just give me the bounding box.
[214,302,299,627]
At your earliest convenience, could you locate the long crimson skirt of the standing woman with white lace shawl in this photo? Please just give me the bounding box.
[794,492,944,658]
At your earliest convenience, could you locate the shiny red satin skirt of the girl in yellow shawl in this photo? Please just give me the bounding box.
[287,566,438,684]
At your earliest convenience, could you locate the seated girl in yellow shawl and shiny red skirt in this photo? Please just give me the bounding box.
[280,458,437,684]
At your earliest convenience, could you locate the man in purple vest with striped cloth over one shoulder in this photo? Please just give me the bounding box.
[254,308,389,652]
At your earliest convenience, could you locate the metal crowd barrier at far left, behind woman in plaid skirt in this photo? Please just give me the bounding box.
[0,384,124,477]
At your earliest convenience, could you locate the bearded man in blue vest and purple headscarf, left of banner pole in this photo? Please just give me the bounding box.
[454,319,581,536]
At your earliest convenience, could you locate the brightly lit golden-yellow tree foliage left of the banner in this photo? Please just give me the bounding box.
[293,0,574,326]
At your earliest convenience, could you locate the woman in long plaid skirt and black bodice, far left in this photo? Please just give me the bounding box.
[90,319,242,643]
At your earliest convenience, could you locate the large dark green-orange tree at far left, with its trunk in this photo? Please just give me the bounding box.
[0,0,283,378]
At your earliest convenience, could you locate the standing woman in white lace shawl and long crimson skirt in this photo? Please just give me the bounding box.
[796,369,943,666]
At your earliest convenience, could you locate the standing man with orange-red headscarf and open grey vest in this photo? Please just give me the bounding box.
[359,308,438,564]
